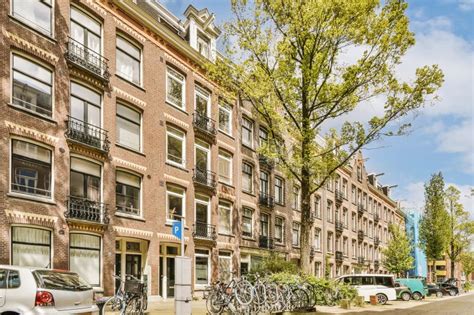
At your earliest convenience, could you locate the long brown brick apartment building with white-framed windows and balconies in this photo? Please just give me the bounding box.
[0,0,404,298]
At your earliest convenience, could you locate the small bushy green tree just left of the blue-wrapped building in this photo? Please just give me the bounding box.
[382,224,415,276]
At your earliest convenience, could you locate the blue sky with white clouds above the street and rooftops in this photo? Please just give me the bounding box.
[161,0,474,218]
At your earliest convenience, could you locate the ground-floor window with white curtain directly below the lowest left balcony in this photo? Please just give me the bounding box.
[69,233,101,287]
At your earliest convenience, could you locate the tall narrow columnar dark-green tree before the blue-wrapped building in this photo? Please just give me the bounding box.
[420,173,449,280]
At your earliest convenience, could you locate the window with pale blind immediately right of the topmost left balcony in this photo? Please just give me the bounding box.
[115,36,141,85]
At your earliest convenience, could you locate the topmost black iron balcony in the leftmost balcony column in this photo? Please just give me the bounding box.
[65,37,110,83]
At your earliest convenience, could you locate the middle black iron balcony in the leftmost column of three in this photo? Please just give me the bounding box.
[65,116,110,153]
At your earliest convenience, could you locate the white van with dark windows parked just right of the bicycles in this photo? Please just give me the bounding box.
[336,274,397,304]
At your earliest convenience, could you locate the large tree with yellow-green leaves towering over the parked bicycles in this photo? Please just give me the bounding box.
[207,0,443,273]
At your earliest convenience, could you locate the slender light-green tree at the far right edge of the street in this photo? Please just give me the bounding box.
[446,186,474,278]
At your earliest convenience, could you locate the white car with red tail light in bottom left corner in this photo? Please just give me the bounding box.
[0,265,99,315]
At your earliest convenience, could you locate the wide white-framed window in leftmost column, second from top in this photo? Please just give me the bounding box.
[12,55,53,118]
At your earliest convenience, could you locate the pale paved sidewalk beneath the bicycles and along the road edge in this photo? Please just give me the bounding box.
[146,291,474,315]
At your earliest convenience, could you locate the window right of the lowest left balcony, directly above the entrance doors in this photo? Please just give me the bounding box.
[115,171,141,215]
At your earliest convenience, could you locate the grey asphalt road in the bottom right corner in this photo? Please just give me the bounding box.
[320,294,474,315]
